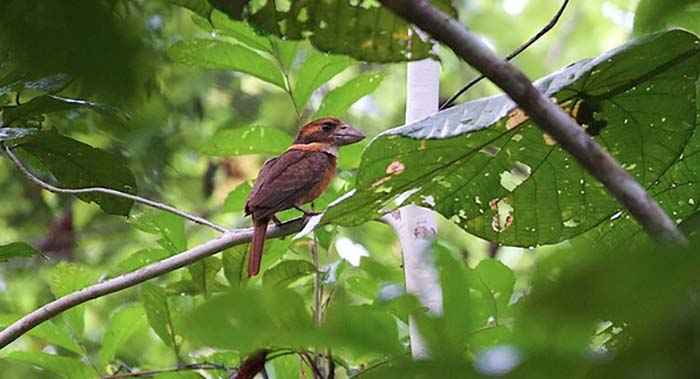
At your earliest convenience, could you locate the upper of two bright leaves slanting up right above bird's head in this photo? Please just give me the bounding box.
[292,51,353,110]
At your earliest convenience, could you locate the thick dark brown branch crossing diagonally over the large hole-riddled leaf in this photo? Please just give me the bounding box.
[380,0,687,244]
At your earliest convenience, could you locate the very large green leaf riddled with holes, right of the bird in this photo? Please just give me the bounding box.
[325,30,700,246]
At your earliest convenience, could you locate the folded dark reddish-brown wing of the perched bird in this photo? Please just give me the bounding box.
[246,150,333,218]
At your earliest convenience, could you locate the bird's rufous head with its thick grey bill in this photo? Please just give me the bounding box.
[294,117,365,146]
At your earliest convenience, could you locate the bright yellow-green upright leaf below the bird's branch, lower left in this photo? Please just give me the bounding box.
[100,304,146,367]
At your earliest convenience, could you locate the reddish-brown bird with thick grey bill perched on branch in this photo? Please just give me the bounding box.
[245,117,365,276]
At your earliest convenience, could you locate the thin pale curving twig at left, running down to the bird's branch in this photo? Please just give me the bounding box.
[0,142,227,233]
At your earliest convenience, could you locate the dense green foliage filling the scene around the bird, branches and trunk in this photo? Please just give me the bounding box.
[0,0,700,378]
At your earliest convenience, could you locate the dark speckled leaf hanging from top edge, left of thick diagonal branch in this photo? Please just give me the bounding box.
[210,0,438,63]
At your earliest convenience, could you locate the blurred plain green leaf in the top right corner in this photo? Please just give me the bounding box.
[634,0,700,34]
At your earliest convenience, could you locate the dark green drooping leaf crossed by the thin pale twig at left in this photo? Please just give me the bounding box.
[19,131,136,216]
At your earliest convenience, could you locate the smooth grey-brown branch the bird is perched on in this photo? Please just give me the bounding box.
[0,218,307,349]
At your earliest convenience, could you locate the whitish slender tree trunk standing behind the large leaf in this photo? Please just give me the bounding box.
[386,59,442,359]
